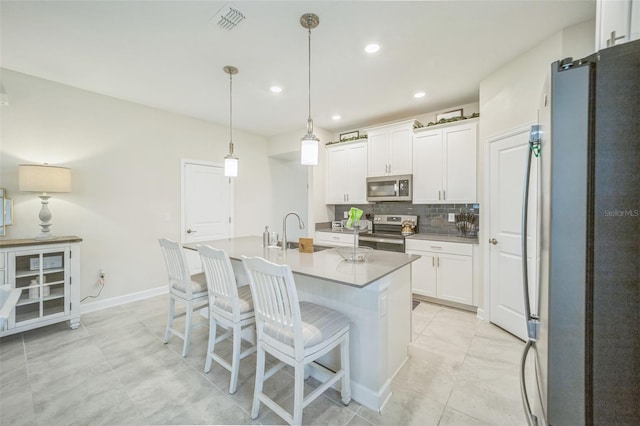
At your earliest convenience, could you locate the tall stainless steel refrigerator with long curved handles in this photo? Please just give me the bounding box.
[521,40,640,426]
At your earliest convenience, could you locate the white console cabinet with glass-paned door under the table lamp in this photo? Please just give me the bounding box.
[0,237,82,336]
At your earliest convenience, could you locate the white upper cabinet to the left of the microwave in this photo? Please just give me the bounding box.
[326,142,367,204]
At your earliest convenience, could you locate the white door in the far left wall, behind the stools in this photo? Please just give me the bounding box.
[182,161,233,273]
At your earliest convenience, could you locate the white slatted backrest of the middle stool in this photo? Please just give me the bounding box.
[198,246,240,322]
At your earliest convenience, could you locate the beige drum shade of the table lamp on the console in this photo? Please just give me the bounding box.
[18,164,71,192]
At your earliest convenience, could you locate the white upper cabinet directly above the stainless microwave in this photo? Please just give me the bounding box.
[365,120,416,177]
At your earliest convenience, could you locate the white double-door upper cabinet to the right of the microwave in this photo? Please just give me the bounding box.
[413,120,478,204]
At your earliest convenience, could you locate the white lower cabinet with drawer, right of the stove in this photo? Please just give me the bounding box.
[405,239,474,305]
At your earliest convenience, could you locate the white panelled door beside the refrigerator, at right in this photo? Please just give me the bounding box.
[489,128,538,340]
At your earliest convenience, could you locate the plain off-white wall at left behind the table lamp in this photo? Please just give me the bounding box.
[0,69,271,303]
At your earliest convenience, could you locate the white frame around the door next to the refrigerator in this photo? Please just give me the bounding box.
[478,121,542,322]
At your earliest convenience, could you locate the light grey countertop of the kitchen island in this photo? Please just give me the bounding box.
[183,236,420,287]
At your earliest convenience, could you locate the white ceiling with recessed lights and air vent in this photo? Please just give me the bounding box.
[0,0,595,136]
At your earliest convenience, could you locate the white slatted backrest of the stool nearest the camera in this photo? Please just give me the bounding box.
[242,256,304,357]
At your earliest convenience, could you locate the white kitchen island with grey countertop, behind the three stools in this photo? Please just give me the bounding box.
[184,237,419,411]
